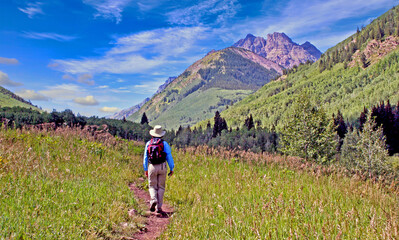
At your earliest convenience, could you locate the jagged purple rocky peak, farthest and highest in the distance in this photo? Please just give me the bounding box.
[233,32,321,68]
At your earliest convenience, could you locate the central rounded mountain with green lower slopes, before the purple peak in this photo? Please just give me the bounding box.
[128,48,281,129]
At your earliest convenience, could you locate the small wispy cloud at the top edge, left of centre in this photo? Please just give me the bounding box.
[83,0,132,24]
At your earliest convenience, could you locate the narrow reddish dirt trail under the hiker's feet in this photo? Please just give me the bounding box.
[129,179,173,240]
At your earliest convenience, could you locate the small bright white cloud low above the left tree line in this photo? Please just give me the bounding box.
[39,84,85,100]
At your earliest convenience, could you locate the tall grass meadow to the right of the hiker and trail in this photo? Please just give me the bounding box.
[164,150,399,239]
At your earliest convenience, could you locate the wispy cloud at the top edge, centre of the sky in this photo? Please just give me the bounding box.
[166,0,240,25]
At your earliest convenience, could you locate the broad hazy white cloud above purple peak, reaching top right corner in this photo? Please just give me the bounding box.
[238,0,396,40]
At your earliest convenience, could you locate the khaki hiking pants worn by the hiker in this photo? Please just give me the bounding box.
[148,162,168,210]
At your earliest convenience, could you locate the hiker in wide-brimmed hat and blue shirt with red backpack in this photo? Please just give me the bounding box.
[143,125,175,213]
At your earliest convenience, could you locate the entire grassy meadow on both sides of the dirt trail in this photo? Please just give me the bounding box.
[0,129,399,239]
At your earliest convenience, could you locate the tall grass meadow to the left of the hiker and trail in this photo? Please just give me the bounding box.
[0,130,144,239]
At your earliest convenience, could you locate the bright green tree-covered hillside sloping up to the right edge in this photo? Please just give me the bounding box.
[222,7,399,127]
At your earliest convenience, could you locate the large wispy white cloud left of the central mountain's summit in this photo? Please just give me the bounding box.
[49,27,208,74]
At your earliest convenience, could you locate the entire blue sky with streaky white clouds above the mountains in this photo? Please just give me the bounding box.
[0,0,398,117]
